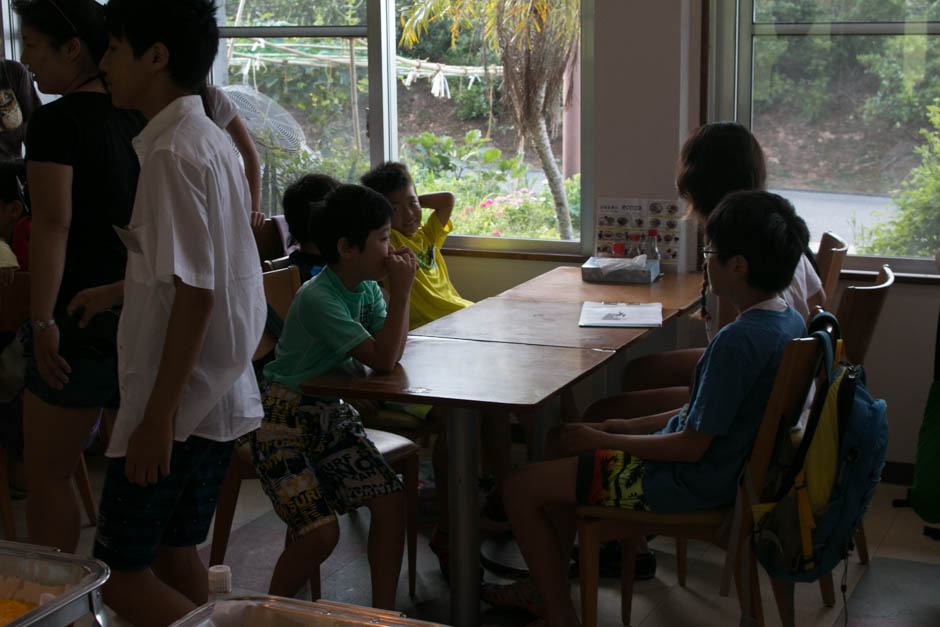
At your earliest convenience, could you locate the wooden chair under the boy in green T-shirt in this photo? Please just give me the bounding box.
[209,266,420,599]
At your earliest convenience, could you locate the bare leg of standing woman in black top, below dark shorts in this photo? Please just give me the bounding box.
[23,390,99,553]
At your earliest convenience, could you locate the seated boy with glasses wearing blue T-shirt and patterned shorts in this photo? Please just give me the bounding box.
[483,191,809,626]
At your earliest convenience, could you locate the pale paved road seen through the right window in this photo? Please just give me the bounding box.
[771,189,897,253]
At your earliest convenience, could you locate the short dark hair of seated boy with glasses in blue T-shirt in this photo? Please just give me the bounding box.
[705,191,809,292]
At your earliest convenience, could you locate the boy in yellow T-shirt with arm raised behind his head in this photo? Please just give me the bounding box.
[360,161,512,577]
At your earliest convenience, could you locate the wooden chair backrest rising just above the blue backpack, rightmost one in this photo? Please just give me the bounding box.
[836,266,894,364]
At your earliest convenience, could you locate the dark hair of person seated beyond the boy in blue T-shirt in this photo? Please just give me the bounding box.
[676,122,767,220]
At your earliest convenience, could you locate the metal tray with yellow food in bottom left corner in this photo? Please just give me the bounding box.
[0,541,111,627]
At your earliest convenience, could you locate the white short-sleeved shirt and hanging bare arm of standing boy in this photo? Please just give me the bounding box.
[107,96,267,457]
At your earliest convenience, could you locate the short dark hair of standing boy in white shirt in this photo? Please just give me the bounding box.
[105,0,219,93]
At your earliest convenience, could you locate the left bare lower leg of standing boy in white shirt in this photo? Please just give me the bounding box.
[102,568,196,627]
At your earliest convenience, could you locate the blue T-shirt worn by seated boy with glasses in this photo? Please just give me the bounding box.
[643,306,806,514]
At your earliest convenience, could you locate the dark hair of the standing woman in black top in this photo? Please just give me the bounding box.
[13,0,108,65]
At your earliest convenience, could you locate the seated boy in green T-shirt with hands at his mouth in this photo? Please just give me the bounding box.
[251,185,417,609]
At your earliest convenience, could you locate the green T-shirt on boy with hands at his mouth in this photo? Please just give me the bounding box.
[264,267,385,392]
